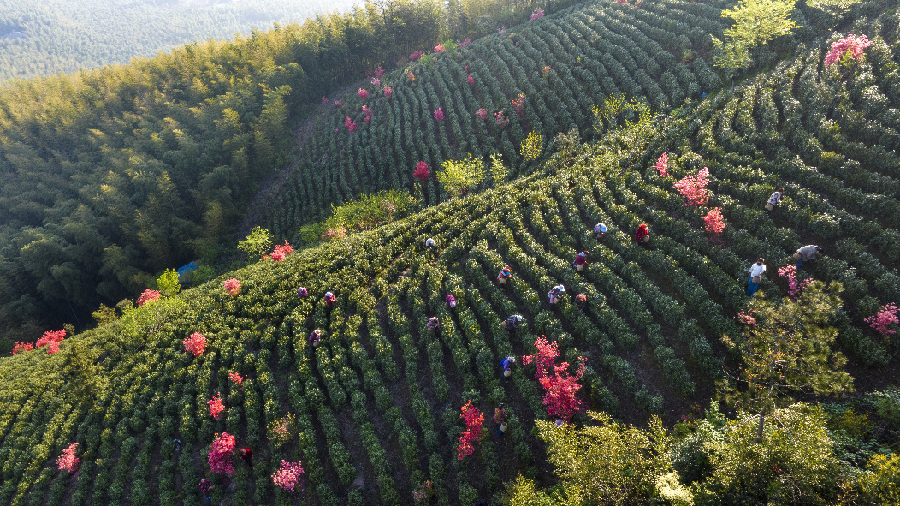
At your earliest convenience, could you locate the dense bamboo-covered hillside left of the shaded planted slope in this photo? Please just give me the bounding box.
[0,0,580,348]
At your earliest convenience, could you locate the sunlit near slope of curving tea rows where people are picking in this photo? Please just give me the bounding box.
[0,0,900,504]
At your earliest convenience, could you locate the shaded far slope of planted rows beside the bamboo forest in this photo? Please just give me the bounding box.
[255,0,725,238]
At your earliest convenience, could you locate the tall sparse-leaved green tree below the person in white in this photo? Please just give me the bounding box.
[723,281,853,438]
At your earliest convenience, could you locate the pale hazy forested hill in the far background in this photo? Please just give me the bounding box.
[0,0,354,81]
